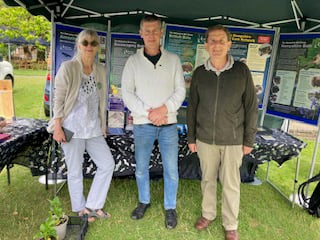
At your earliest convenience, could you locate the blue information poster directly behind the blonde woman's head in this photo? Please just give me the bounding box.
[54,23,107,74]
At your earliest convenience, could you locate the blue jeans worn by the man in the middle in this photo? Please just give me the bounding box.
[133,124,179,210]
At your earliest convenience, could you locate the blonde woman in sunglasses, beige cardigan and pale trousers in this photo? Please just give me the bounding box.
[48,30,114,221]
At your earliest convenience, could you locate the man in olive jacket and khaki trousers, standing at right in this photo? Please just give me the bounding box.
[187,25,258,240]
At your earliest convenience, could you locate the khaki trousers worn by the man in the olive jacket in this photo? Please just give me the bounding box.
[197,140,243,231]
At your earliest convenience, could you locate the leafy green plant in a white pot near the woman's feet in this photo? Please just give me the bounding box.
[48,197,68,240]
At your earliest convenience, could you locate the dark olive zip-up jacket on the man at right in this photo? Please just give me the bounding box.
[187,62,258,147]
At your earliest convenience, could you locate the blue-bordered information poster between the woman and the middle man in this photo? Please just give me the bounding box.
[108,33,143,134]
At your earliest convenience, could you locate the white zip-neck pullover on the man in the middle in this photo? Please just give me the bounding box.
[121,48,186,124]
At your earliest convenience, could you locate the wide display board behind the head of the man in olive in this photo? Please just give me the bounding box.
[164,24,275,108]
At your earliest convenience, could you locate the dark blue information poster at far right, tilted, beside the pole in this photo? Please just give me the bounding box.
[267,33,320,125]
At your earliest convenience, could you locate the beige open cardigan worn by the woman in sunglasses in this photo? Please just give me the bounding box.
[47,57,107,135]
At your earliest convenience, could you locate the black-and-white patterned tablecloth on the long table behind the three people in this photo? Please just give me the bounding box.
[34,129,305,182]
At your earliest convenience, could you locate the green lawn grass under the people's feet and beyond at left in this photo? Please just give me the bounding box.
[0,70,320,240]
